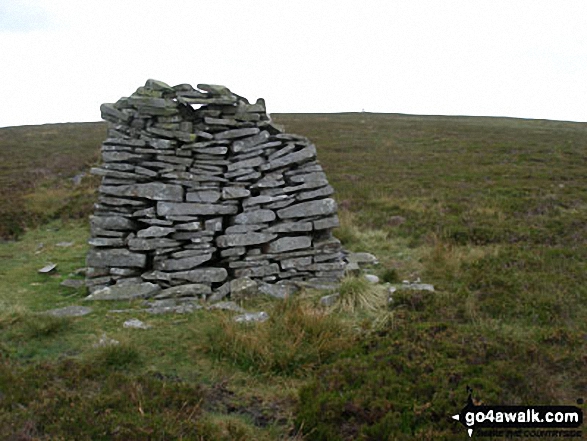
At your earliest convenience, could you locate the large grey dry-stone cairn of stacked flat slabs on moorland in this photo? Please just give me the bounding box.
[86,80,345,300]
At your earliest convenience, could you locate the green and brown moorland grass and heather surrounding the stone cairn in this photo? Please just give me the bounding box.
[0,113,587,440]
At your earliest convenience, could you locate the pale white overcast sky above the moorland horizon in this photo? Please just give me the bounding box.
[0,0,587,127]
